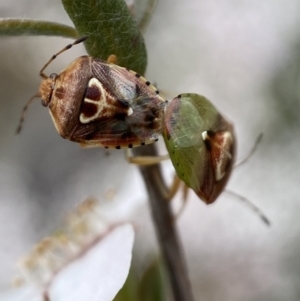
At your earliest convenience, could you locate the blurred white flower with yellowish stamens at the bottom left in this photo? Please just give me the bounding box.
[0,199,134,301]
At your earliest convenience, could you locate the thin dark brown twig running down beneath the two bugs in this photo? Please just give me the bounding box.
[133,145,194,301]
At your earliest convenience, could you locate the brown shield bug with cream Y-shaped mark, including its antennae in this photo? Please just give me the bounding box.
[17,37,166,149]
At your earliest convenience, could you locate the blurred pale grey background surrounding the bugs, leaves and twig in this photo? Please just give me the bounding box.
[0,0,300,301]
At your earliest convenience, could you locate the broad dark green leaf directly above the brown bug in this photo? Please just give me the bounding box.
[62,0,147,74]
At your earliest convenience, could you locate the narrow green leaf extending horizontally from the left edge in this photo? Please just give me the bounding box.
[0,19,78,38]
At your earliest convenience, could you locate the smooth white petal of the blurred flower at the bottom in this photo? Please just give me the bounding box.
[49,224,134,301]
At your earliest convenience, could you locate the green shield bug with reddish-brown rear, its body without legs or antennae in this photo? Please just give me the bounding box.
[163,94,236,204]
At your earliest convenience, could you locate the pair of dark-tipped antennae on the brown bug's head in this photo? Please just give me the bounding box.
[16,36,88,134]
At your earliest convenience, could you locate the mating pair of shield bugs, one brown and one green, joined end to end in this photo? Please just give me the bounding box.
[18,37,264,218]
